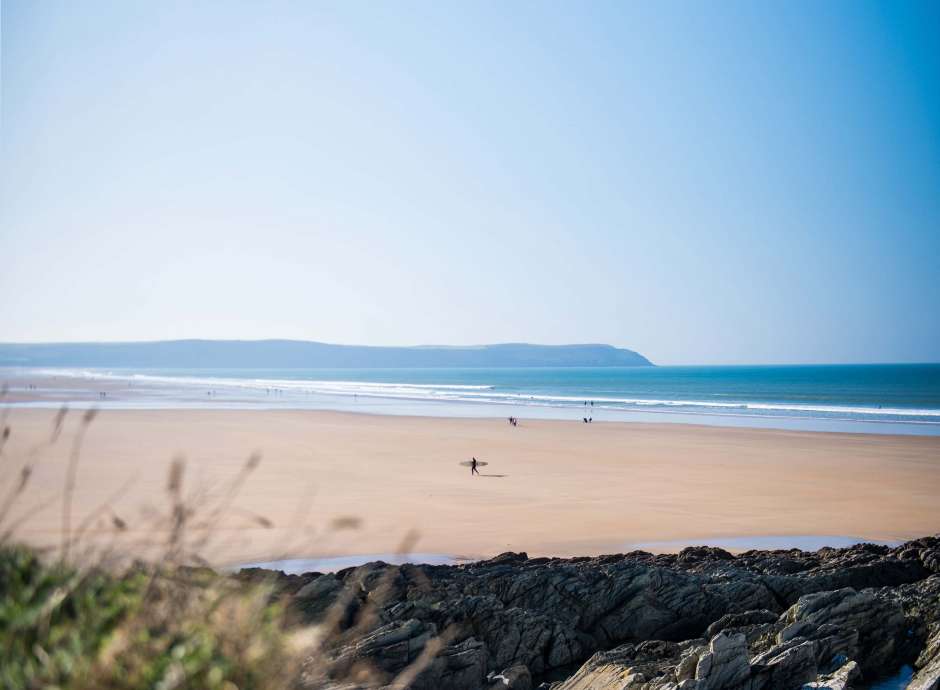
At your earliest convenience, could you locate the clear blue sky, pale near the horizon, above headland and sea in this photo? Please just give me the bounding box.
[0,0,940,363]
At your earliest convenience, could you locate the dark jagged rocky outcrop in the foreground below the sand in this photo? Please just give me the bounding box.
[244,537,940,690]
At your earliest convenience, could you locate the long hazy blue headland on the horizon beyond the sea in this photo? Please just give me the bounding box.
[0,340,653,368]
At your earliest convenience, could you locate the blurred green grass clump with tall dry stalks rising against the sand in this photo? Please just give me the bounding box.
[0,406,324,690]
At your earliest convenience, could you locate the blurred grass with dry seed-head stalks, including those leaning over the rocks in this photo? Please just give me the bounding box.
[0,411,452,690]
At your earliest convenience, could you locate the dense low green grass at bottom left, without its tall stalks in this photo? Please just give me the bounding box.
[0,546,304,690]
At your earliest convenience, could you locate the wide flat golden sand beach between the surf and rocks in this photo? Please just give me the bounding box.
[0,409,940,564]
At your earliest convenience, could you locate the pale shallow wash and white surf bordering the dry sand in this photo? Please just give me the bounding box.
[0,367,940,436]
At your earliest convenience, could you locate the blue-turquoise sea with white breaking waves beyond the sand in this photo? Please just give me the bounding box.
[7,364,940,435]
